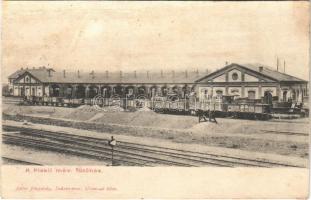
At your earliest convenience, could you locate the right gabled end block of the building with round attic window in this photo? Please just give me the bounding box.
[196,63,309,102]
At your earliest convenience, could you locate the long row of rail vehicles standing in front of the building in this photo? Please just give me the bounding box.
[22,96,271,119]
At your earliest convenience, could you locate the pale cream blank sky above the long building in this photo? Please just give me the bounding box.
[2,1,309,80]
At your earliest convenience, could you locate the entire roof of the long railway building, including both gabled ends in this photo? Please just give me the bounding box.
[9,63,307,84]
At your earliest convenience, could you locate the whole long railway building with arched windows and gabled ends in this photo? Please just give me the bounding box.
[8,63,309,102]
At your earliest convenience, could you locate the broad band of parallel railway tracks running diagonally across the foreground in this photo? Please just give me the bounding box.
[3,125,301,167]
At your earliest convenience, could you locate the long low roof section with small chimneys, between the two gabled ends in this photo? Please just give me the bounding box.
[11,69,207,84]
